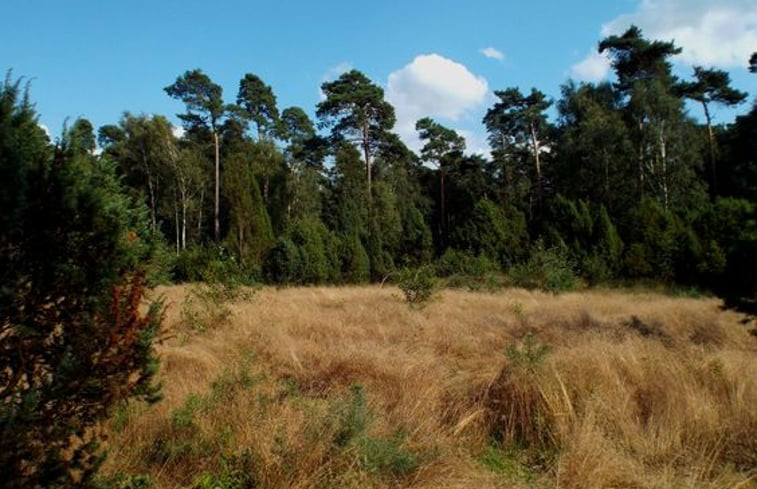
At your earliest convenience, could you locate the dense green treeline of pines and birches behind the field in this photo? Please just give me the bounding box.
[4,27,757,296]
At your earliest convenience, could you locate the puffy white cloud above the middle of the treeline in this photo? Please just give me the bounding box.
[386,54,489,151]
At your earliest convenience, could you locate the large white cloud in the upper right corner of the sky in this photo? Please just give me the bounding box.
[602,0,757,68]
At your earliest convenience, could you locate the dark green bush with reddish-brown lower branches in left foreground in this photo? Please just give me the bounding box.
[0,76,161,488]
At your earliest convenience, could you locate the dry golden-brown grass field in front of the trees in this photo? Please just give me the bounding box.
[103,286,757,489]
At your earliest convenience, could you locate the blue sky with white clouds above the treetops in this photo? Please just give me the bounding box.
[0,0,757,150]
